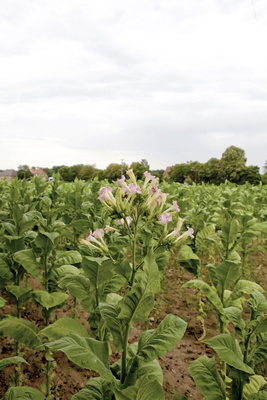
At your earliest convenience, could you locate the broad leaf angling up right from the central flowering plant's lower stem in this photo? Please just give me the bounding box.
[137,314,187,362]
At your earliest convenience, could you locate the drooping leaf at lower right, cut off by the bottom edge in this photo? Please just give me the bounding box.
[189,355,226,400]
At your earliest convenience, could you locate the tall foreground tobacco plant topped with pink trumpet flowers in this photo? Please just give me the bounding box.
[47,170,193,400]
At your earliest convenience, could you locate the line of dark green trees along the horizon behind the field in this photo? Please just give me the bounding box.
[18,146,267,185]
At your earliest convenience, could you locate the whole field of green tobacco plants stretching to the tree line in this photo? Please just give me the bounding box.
[0,175,267,400]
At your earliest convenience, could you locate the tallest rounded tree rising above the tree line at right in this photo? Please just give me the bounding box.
[219,146,247,183]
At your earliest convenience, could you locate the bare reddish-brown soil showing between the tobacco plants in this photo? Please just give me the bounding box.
[0,250,267,400]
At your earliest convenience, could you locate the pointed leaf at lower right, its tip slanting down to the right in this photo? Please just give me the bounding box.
[204,333,254,375]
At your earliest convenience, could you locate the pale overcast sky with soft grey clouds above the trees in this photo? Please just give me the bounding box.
[0,0,267,169]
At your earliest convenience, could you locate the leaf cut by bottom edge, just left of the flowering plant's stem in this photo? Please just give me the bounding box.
[71,378,113,400]
